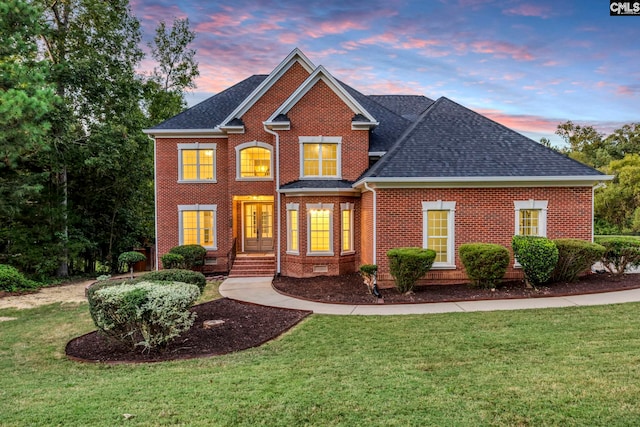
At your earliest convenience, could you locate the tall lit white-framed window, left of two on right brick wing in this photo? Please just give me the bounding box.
[422,200,456,268]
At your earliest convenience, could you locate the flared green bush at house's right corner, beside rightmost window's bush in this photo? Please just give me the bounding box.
[551,239,606,282]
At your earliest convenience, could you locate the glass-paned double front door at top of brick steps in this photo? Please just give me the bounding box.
[244,203,273,252]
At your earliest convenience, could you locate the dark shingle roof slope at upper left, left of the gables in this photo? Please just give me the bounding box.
[152,75,267,129]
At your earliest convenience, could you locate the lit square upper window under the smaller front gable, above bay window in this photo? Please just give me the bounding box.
[300,136,342,178]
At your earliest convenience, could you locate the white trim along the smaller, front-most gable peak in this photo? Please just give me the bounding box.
[267,65,379,126]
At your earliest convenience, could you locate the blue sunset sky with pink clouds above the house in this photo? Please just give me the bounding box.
[131,0,640,145]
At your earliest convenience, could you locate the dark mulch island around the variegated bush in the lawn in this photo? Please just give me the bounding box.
[66,298,311,363]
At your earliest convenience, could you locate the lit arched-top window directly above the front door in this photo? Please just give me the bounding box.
[236,141,273,181]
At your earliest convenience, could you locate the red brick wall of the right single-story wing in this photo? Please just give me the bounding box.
[372,187,592,288]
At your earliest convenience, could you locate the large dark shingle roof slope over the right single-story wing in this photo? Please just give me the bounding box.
[363,97,602,178]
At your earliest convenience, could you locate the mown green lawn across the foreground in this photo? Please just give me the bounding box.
[0,304,640,426]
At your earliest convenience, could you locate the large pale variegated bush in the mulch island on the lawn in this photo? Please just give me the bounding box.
[89,282,200,351]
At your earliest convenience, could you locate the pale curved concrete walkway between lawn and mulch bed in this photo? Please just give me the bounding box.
[220,277,640,315]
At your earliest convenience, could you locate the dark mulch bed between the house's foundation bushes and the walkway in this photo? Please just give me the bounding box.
[273,273,640,304]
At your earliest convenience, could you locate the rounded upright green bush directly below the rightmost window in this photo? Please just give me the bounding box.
[511,236,558,286]
